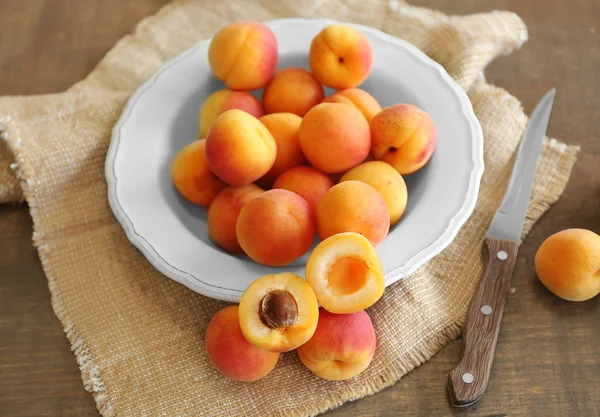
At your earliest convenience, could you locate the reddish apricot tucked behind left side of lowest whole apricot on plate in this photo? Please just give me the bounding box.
[207,184,264,254]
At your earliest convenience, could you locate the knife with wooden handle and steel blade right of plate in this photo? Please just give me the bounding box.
[448,88,556,407]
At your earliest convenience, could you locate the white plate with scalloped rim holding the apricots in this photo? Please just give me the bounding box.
[106,19,483,302]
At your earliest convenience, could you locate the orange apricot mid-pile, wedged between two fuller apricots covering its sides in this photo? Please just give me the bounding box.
[258,113,308,188]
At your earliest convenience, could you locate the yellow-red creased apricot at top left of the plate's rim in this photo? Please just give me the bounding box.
[208,20,278,90]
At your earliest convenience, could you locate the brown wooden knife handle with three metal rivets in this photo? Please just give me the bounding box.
[448,238,519,407]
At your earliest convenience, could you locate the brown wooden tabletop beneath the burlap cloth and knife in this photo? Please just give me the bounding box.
[0,0,600,417]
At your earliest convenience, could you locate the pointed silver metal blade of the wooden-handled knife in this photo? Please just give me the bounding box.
[487,88,556,242]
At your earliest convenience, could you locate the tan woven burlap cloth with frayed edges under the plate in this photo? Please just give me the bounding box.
[0,0,578,417]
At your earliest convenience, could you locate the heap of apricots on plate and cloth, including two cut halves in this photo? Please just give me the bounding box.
[171,21,436,381]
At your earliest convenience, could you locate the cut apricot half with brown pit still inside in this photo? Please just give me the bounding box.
[240,272,319,352]
